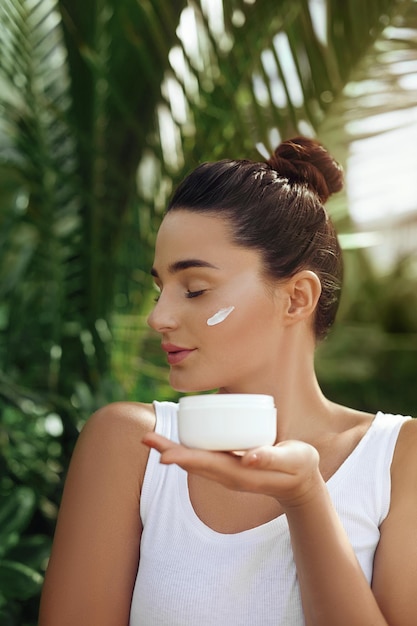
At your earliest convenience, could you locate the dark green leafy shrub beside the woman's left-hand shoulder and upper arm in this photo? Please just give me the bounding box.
[0,375,126,626]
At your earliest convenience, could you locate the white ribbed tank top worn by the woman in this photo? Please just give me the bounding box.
[130,402,410,626]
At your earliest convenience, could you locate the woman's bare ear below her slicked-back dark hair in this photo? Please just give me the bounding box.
[284,270,321,324]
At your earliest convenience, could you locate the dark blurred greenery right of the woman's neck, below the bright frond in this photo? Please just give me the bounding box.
[317,253,417,416]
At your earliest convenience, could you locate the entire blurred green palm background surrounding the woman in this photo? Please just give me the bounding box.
[0,0,417,626]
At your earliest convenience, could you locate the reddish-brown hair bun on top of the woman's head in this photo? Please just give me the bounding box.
[267,137,343,203]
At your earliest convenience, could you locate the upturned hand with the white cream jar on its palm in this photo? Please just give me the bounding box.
[143,433,323,510]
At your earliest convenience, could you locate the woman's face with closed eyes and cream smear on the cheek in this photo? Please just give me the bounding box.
[148,210,282,393]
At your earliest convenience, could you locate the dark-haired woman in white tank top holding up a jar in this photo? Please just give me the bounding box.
[40,137,417,626]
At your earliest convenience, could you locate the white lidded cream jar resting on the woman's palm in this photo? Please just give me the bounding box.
[178,393,277,450]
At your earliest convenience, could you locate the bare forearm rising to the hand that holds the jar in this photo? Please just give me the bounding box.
[286,470,388,626]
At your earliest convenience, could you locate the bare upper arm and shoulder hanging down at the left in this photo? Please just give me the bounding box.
[39,403,154,626]
